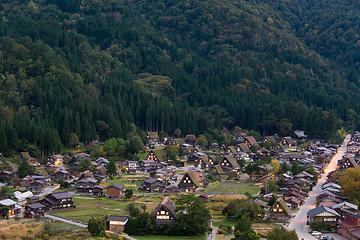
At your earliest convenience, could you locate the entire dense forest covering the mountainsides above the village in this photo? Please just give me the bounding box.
[0,0,360,155]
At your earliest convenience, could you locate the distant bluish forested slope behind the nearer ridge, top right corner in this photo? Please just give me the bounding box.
[267,0,360,87]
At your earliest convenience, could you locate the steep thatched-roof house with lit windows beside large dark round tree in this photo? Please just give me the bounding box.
[151,197,177,225]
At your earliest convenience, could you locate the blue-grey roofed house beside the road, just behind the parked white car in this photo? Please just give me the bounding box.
[307,205,340,227]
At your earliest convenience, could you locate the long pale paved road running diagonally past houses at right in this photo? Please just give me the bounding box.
[289,135,350,240]
